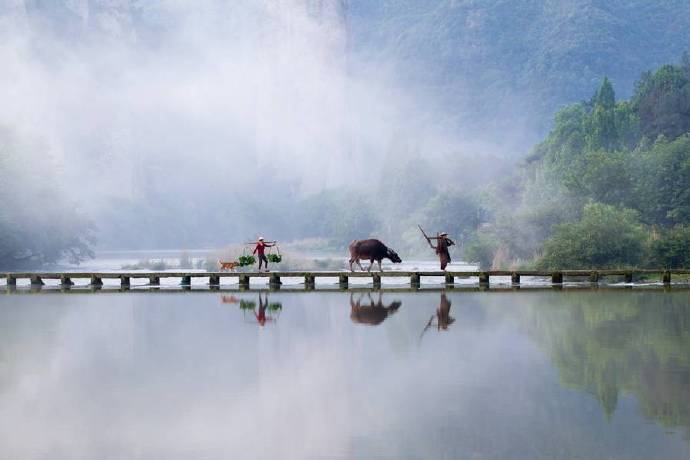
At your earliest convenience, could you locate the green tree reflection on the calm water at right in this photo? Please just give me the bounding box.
[522,293,690,436]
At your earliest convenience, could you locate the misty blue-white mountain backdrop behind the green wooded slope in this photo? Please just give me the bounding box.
[0,0,690,260]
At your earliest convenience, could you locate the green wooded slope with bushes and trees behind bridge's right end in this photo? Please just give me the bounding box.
[468,54,690,268]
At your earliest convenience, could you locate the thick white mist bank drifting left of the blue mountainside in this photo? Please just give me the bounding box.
[0,0,510,255]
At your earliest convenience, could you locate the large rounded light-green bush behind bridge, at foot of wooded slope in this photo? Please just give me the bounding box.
[538,203,647,269]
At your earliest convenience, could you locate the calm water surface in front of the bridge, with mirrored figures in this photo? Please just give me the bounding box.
[0,289,690,459]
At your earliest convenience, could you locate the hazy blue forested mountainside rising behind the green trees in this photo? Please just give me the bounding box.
[350,0,690,144]
